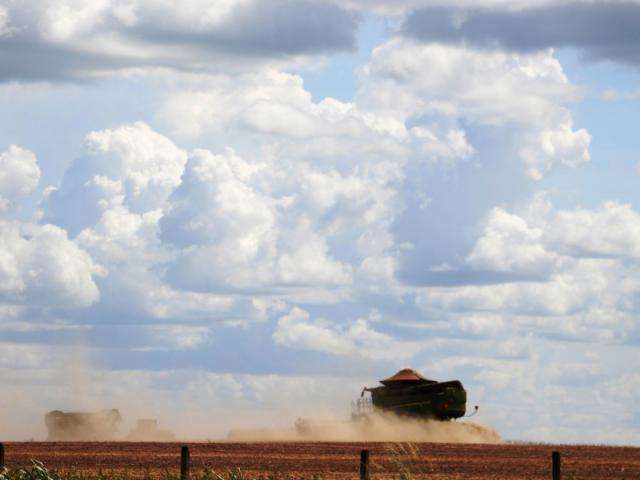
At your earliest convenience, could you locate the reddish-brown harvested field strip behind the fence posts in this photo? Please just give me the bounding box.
[5,442,640,480]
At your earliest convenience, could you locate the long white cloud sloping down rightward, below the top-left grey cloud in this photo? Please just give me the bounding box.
[158,69,474,170]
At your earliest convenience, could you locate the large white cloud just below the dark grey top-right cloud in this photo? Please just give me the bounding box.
[358,38,591,179]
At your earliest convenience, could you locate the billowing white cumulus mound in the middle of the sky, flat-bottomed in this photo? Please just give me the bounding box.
[161,146,402,291]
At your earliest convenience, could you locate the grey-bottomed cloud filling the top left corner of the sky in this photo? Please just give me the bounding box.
[0,0,357,81]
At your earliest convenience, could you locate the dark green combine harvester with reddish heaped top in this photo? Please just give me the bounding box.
[352,368,478,420]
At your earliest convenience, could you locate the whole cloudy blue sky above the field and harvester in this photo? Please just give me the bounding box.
[0,0,640,445]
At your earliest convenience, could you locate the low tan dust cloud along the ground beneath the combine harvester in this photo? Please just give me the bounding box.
[227,412,502,444]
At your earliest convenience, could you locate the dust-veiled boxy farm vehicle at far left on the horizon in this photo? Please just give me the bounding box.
[44,408,122,441]
